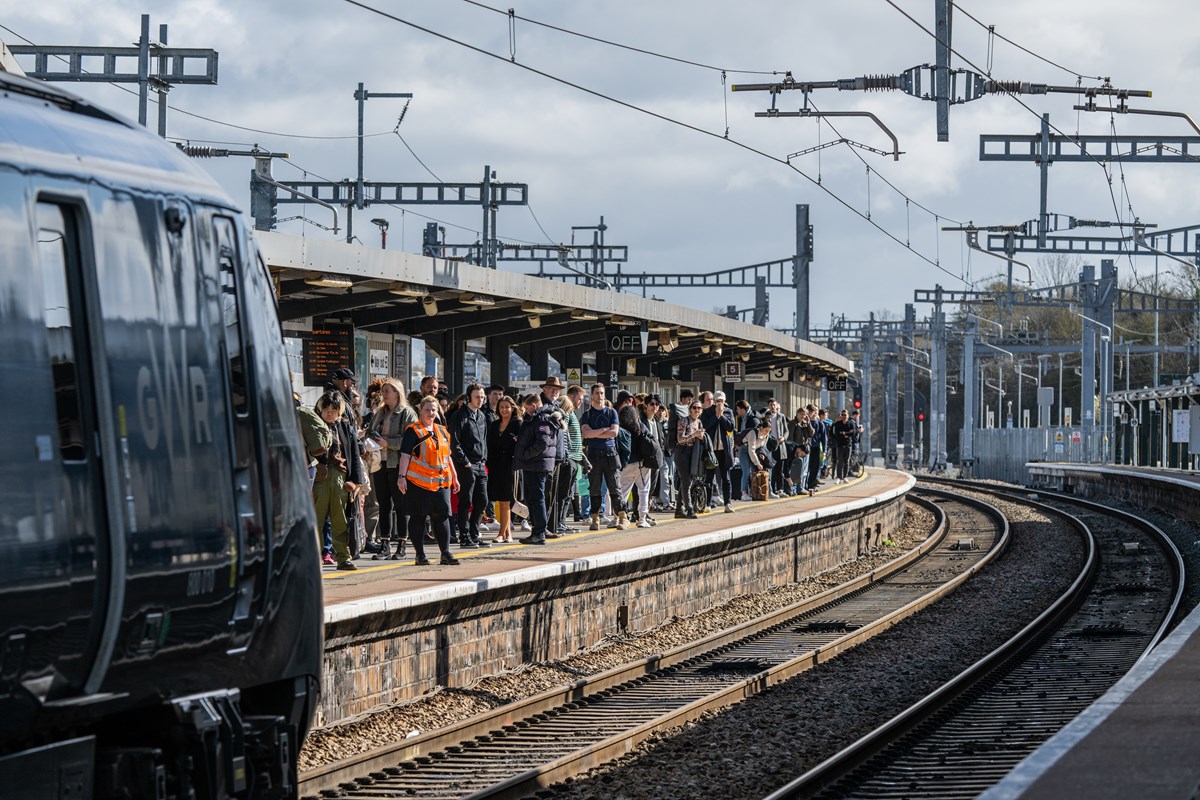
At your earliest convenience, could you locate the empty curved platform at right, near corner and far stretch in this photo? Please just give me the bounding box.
[980,463,1200,800]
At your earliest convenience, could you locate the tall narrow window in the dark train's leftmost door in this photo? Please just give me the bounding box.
[37,203,86,462]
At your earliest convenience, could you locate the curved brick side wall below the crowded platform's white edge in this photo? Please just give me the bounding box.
[314,495,904,726]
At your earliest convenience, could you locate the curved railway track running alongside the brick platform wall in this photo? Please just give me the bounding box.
[301,491,1008,798]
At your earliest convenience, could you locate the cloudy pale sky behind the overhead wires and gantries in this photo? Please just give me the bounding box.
[0,0,1200,326]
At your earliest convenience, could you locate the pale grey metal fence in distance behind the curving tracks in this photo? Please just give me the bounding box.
[971,427,1106,483]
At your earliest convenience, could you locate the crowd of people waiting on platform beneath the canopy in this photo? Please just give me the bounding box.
[296,368,862,570]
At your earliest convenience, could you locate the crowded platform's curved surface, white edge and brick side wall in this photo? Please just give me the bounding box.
[316,470,916,726]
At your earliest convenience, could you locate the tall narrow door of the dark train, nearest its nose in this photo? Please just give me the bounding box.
[211,216,271,633]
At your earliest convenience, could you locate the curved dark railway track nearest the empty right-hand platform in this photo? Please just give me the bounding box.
[768,482,1183,800]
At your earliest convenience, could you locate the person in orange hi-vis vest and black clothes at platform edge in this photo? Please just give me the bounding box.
[396,395,458,566]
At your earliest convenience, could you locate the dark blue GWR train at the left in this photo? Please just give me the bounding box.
[0,72,323,800]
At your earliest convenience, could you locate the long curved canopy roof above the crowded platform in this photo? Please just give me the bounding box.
[256,231,853,378]
